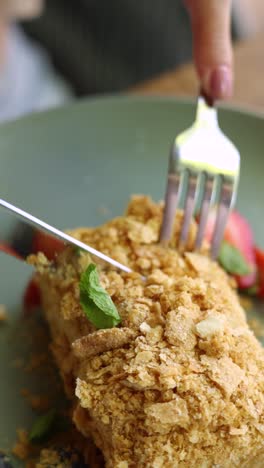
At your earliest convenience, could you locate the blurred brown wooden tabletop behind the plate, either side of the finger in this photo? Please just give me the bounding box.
[132,34,264,111]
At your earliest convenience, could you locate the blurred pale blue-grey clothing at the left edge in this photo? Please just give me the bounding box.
[0,26,72,121]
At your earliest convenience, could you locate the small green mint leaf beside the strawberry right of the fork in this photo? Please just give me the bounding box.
[218,241,251,276]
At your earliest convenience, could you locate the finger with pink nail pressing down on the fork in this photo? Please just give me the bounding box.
[185,0,233,99]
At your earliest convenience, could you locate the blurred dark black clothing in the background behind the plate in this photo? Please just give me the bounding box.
[24,0,192,95]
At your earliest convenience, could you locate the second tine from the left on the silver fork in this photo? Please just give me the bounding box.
[179,174,199,247]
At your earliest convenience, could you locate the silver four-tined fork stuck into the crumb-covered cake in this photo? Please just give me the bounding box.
[160,96,240,259]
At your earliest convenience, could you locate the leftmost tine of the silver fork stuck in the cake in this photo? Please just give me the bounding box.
[160,172,183,243]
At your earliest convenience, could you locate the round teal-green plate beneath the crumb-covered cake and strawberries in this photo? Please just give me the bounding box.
[0,97,264,466]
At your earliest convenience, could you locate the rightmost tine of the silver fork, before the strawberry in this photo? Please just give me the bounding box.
[211,180,234,259]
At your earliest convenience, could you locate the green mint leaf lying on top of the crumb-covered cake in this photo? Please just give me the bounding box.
[80,263,121,329]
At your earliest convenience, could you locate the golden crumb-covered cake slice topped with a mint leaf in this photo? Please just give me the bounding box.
[29,196,264,468]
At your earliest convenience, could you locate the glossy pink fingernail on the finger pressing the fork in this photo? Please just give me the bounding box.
[208,65,232,99]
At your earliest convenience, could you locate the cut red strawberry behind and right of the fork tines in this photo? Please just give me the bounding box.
[206,210,257,289]
